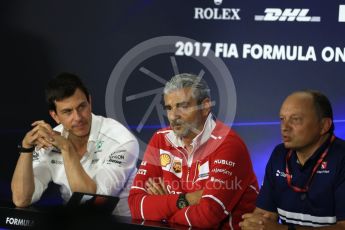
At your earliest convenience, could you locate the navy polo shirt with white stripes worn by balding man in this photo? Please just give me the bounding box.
[257,138,345,227]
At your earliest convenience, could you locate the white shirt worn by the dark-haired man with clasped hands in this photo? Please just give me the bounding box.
[32,114,139,216]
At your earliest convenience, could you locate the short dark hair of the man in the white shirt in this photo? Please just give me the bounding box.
[45,72,89,112]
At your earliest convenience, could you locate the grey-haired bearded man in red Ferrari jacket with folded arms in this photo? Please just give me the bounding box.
[128,74,258,229]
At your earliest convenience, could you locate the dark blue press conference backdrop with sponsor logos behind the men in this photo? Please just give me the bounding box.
[0,0,345,204]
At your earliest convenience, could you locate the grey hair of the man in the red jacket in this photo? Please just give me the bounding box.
[163,73,211,103]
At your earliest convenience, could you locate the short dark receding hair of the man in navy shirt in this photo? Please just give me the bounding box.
[305,90,335,133]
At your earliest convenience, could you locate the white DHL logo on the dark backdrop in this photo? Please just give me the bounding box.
[254,8,321,22]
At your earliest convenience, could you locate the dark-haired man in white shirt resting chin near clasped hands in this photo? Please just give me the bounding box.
[11,73,139,216]
